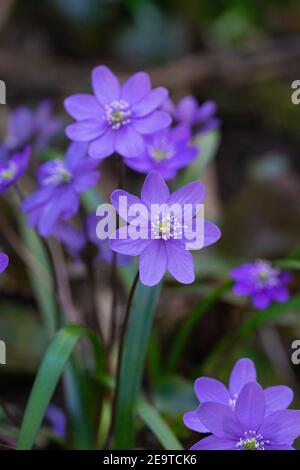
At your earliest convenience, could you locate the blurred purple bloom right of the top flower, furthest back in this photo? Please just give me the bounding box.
[163,96,220,134]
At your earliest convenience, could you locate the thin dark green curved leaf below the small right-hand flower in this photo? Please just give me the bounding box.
[167,280,232,373]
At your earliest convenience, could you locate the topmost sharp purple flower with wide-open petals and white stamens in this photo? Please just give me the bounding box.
[65,66,171,159]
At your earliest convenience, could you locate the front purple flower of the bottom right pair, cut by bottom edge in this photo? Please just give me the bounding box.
[192,382,300,450]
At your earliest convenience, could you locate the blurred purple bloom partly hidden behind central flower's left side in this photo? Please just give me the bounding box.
[86,213,131,266]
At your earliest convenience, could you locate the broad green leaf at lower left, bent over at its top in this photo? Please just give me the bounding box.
[17,325,103,450]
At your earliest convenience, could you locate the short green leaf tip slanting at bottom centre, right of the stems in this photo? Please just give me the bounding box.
[137,399,183,450]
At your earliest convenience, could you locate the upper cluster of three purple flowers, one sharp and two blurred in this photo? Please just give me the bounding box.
[65,66,219,179]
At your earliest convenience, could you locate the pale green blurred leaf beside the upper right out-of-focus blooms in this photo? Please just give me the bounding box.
[178,130,221,186]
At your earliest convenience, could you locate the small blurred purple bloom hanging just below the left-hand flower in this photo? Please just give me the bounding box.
[52,220,86,258]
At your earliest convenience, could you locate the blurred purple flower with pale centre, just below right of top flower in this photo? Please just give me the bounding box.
[125,126,198,180]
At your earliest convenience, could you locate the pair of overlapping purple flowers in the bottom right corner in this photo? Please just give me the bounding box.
[184,359,300,450]
